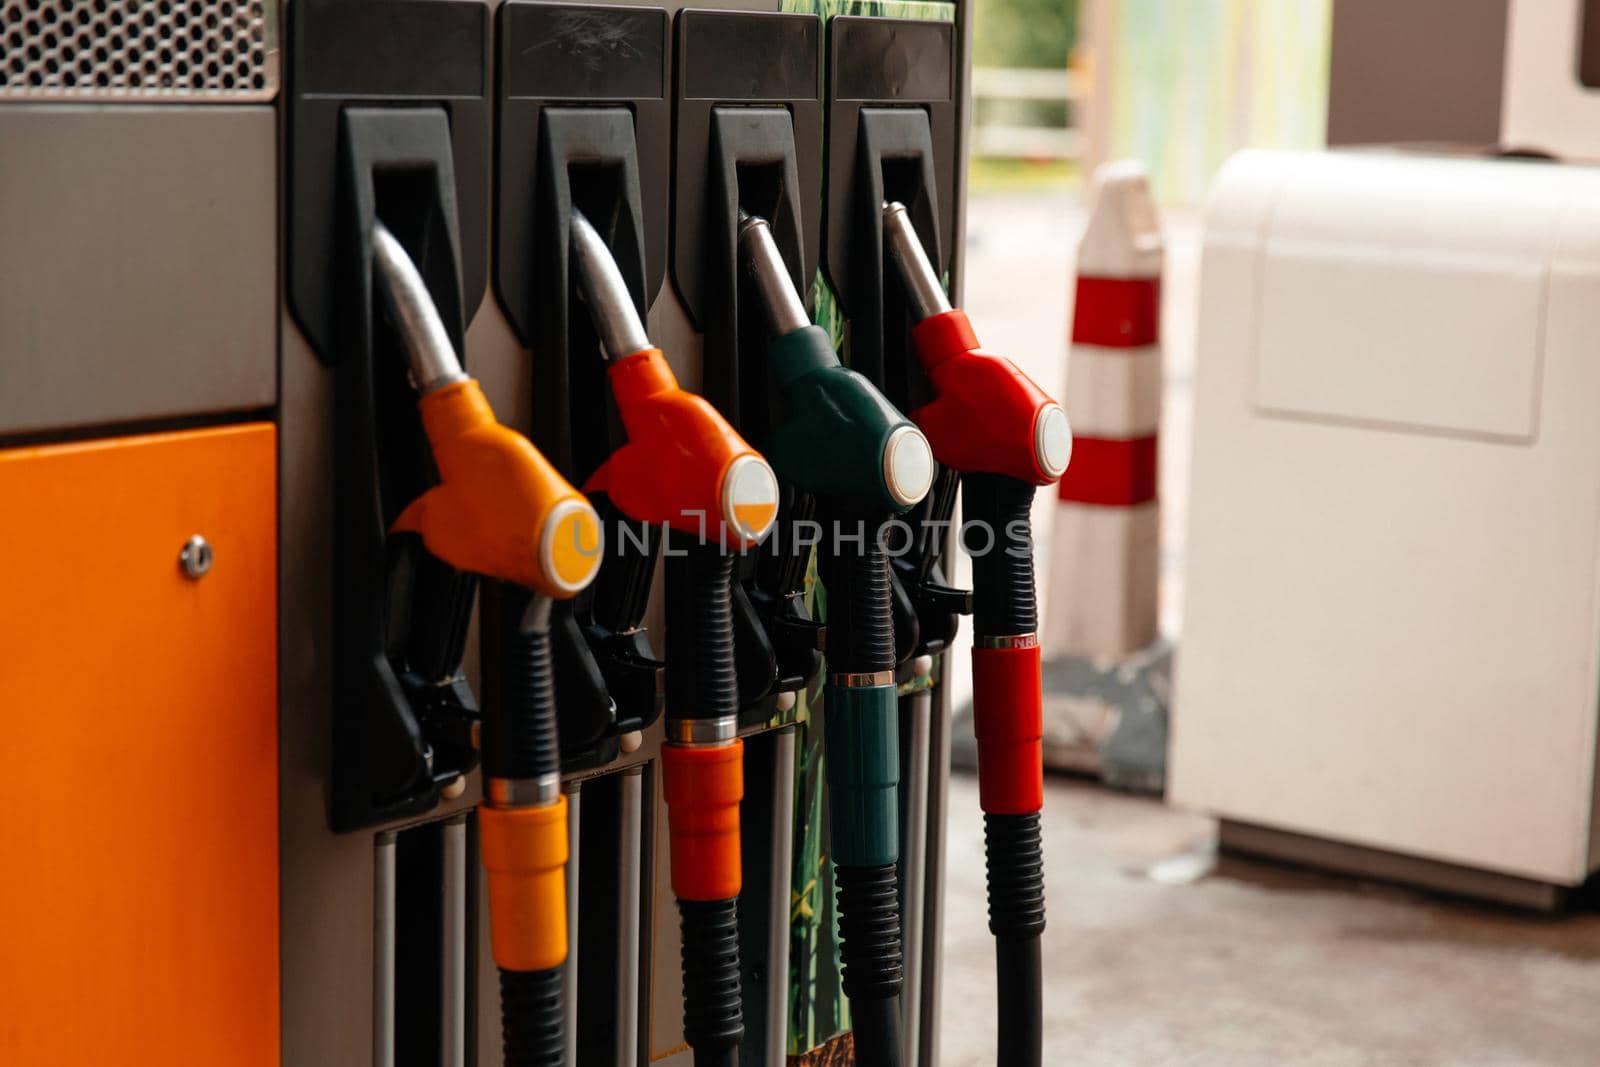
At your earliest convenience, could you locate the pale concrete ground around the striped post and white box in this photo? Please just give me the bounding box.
[941,190,1600,1067]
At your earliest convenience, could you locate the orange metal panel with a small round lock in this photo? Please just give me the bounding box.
[0,424,278,1067]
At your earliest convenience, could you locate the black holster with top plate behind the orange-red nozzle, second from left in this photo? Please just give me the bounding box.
[494,0,670,771]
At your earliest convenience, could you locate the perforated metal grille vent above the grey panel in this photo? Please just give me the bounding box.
[0,0,278,101]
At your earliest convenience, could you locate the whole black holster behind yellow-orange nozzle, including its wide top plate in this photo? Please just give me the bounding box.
[285,0,490,832]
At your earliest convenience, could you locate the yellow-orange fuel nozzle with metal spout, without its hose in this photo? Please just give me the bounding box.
[373,222,602,600]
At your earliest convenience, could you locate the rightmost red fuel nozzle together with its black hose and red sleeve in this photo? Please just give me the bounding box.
[883,202,1072,1067]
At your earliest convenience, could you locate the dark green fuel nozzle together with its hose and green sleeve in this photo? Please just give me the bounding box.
[739,214,934,1067]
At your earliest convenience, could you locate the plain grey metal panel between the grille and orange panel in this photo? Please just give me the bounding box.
[0,104,277,434]
